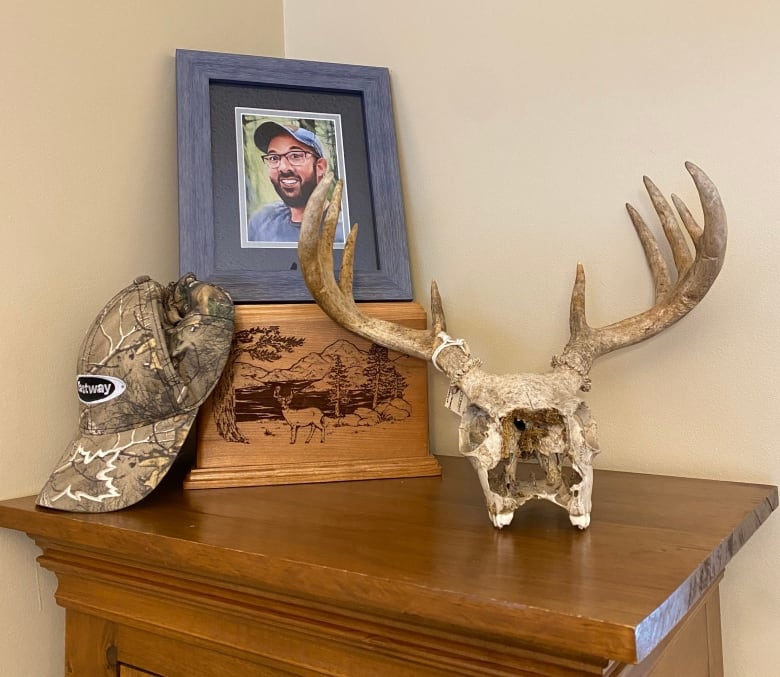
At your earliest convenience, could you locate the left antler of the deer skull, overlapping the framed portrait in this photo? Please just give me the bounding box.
[298,172,445,360]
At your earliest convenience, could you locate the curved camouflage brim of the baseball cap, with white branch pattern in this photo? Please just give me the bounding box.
[36,410,197,512]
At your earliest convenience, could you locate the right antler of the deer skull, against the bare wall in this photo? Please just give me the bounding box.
[554,162,727,377]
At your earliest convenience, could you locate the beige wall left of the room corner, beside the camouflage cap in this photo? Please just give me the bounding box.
[0,0,283,677]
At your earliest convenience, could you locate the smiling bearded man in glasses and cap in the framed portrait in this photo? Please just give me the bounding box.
[247,122,344,243]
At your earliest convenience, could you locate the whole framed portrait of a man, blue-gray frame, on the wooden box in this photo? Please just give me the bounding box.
[176,50,412,303]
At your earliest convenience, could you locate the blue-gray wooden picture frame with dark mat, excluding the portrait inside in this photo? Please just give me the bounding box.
[176,49,412,303]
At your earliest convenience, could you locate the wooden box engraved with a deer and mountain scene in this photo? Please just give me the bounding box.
[184,302,441,489]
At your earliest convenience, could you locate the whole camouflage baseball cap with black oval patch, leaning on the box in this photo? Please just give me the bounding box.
[36,274,234,512]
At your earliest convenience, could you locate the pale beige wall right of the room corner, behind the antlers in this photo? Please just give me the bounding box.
[285,0,780,677]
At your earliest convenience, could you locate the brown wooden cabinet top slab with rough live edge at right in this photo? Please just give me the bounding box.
[0,457,778,662]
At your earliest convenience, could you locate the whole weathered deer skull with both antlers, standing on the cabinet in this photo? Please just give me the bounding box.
[298,162,726,529]
